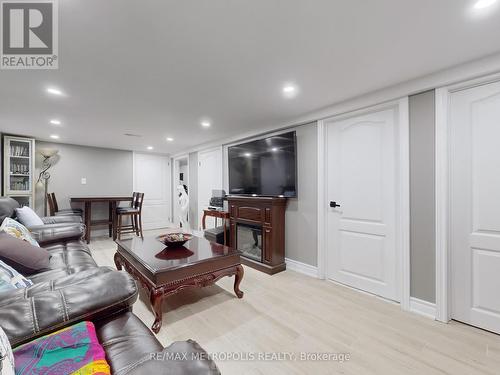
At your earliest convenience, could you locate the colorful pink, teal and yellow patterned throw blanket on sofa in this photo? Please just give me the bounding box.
[14,322,110,375]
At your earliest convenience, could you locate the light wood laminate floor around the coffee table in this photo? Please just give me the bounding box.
[90,231,500,375]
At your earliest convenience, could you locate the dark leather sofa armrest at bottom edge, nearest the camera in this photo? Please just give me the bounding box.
[116,340,220,375]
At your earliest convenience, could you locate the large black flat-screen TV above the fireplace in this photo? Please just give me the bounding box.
[228,132,297,197]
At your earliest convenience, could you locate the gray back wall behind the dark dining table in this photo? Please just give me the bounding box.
[35,142,133,222]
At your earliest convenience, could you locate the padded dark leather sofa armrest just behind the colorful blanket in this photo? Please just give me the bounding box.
[0,267,138,347]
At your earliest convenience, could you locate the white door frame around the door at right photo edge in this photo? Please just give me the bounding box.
[436,73,500,323]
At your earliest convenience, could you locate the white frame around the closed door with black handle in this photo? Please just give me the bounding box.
[318,97,410,310]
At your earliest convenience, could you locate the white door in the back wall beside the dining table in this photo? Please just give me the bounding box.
[134,153,171,229]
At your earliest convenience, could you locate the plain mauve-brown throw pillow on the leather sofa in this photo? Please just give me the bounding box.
[0,231,49,275]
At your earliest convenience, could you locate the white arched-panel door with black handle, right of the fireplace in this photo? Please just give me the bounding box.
[326,109,399,301]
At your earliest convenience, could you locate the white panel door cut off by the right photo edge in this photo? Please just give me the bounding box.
[450,82,500,333]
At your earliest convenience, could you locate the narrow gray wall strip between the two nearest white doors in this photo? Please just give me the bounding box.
[409,90,436,303]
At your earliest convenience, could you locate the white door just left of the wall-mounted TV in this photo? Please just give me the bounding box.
[198,148,222,228]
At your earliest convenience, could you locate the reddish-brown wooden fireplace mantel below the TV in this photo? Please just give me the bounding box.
[227,196,287,275]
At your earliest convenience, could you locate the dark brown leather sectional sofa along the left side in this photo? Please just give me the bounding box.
[0,198,220,375]
